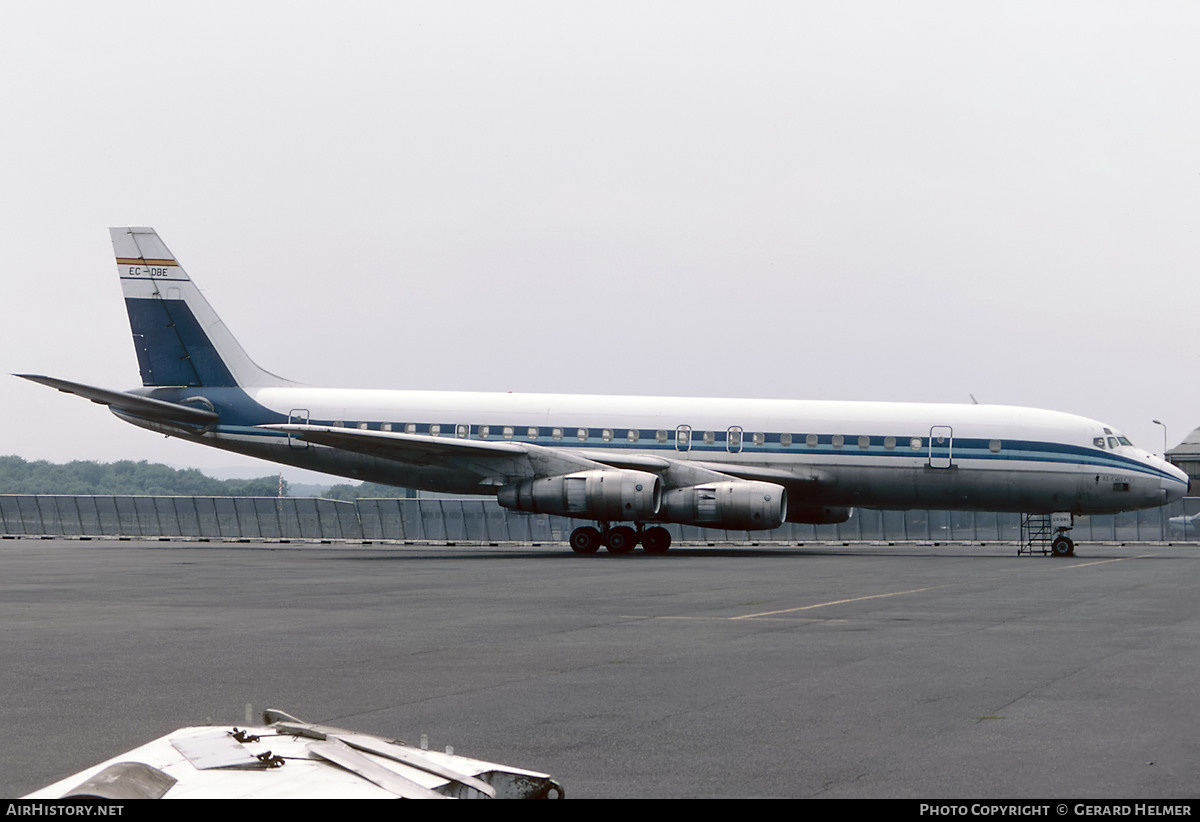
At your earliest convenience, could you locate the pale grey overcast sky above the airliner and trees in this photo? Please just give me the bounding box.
[0,0,1200,474]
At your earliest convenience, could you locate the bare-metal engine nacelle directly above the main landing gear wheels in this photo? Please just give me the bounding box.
[496,468,662,522]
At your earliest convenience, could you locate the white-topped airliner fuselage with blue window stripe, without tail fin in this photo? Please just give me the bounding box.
[125,386,1187,514]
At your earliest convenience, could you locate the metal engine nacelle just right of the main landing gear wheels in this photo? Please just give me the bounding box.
[659,480,787,530]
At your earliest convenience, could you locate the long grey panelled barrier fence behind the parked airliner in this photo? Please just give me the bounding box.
[0,494,1200,544]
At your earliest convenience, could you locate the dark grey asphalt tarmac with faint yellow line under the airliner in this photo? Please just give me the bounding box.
[0,539,1200,799]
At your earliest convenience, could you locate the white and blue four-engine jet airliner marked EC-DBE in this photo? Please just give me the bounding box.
[16,227,1188,556]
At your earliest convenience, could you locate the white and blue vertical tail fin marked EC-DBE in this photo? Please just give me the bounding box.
[108,227,290,388]
